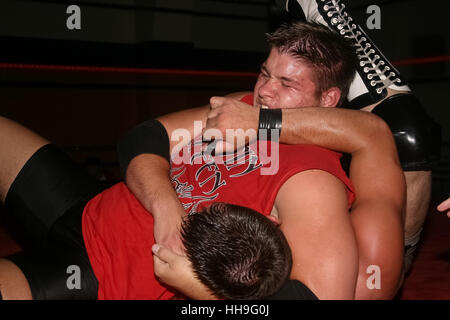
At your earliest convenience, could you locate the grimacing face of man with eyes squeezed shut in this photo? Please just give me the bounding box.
[254,48,323,109]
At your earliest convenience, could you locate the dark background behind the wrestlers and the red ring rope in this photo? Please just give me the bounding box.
[0,0,450,196]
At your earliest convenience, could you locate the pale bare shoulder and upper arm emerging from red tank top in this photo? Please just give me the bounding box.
[275,170,358,299]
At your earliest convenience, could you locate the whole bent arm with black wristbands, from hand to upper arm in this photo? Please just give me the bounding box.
[207,99,406,299]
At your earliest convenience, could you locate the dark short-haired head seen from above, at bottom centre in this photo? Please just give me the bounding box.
[182,203,292,300]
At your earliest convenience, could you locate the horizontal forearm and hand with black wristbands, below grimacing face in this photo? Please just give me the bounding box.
[206,98,395,154]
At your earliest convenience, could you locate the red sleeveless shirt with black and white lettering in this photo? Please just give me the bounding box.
[82,97,354,300]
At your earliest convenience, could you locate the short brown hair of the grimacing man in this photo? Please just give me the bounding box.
[267,21,357,104]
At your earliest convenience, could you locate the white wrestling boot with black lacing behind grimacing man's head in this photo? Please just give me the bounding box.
[275,0,411,109]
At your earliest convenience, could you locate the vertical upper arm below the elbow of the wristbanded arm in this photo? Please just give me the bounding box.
[350,131,406,299]
